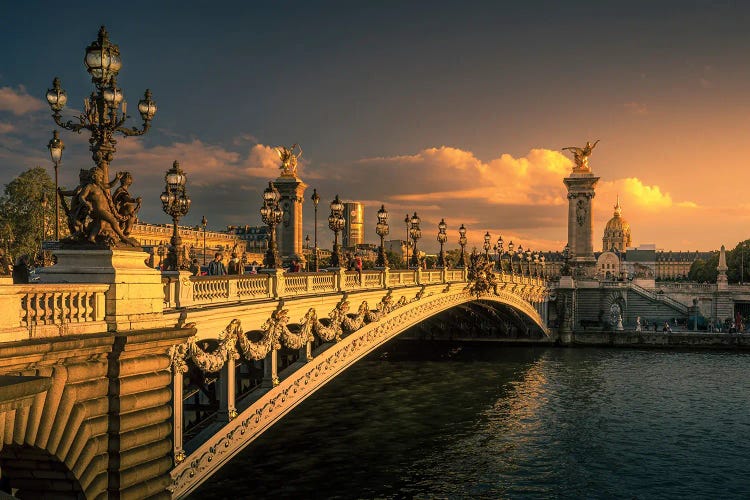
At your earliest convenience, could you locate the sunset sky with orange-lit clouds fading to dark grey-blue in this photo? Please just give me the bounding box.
[0,0,750,251]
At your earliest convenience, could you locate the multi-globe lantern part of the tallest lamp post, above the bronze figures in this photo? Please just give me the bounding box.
[46,26,156,245]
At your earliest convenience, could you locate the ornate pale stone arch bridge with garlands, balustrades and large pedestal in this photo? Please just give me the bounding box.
[0,250,550,498]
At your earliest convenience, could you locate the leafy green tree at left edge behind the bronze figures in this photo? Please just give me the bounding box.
[0,167,60,264]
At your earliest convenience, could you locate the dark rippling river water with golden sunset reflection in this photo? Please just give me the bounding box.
[192,341,750,500]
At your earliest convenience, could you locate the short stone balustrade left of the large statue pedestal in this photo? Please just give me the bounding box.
[0,283,109,342]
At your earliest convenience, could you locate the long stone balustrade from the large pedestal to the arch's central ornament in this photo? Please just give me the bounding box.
[162,269,470,309]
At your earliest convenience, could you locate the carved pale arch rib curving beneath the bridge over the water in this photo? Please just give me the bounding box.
[170,288,549,498]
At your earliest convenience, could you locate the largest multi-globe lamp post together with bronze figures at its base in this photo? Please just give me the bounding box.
[45,26,156,247]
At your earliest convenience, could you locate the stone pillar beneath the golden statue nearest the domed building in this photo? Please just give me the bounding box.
[563,164,599,277]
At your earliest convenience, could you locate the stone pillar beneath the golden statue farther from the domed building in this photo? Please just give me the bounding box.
[273,173,307,263]
